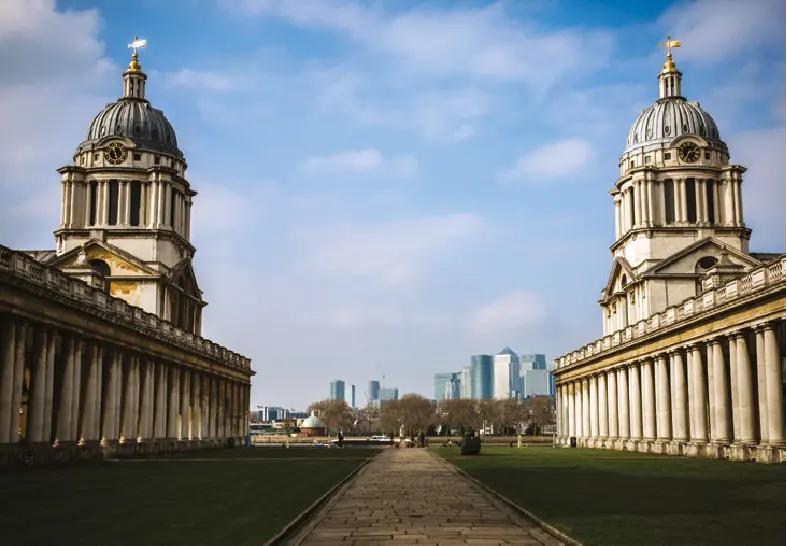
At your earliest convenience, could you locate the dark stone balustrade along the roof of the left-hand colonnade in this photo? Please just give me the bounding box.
[0,245,251,370]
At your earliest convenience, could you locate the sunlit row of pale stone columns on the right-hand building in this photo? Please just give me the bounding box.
[557,321,785,459]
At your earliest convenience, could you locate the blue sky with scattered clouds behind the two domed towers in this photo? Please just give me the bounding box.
[0,0,787,407]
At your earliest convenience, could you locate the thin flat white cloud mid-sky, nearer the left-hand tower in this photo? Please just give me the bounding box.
[301,149,418,175]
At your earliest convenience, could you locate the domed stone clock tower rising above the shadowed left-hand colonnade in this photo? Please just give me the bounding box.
[50,39,206,334]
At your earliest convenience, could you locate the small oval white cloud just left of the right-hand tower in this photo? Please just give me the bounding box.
[502,139,593,182]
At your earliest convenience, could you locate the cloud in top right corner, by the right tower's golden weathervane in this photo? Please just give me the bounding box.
[657,0,787,63]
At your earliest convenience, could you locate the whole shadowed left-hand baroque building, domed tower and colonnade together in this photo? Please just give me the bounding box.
[0,40,254,465]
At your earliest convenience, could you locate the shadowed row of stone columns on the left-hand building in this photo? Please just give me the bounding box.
[0,316,249,448]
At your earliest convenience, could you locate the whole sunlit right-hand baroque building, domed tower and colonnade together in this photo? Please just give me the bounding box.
[553,42,787,463]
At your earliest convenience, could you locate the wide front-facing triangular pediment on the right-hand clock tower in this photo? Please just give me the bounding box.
[642,237,760,277]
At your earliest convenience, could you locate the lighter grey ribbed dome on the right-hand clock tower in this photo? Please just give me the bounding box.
[626,97,721,148]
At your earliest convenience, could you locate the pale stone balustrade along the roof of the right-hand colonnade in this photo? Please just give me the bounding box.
[556,256,787,369]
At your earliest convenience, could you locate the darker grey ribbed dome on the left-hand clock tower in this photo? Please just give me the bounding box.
[86,97,183,157]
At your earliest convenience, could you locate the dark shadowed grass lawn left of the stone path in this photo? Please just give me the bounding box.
[0,448,377,546]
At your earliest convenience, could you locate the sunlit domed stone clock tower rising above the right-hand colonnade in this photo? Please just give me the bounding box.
[599,37,760,335]
